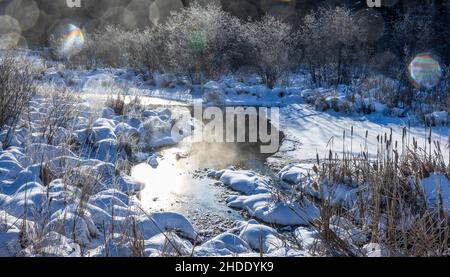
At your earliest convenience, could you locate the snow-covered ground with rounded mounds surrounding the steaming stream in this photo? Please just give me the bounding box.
[0,52,450,256]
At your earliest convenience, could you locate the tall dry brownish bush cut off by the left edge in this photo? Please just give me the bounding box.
[0,55,34,146]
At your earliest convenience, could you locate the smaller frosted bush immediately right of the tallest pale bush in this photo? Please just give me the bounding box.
[242,16,296,88]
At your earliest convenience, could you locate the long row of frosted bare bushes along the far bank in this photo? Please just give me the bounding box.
[71,2,450,91]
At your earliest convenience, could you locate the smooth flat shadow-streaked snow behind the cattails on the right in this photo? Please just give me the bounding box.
[280,103,449,163]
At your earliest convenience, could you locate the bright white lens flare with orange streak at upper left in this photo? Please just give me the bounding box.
[55,24,85,58]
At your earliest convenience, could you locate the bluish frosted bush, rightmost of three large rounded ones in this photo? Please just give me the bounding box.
[300,7,370,84]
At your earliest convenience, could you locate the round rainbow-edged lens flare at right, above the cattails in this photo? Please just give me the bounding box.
[408,53,442,89]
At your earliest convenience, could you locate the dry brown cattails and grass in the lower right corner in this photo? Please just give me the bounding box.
[313,126,450,256]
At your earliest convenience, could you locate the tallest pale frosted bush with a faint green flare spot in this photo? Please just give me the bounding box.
[165,2,243,83]
